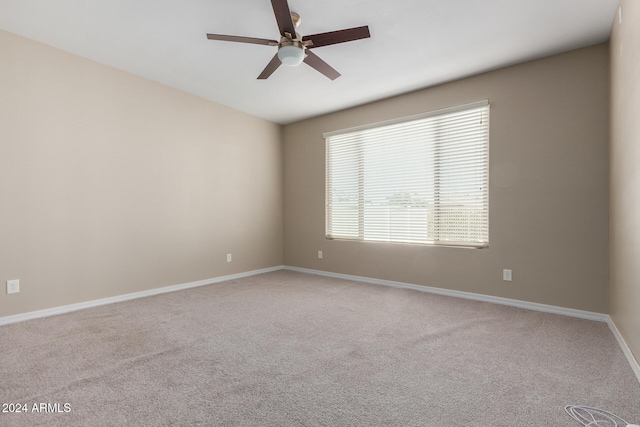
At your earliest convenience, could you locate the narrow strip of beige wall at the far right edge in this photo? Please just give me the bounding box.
[610,0,640,360]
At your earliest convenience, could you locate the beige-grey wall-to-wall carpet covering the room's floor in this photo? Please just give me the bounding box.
[0,270,640,427]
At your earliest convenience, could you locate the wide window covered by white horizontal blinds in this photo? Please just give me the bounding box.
[324,101,489,247]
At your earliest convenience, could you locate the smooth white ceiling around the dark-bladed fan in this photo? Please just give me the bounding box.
[0,0,618,124]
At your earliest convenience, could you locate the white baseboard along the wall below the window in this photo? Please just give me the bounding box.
[284,266,609,322]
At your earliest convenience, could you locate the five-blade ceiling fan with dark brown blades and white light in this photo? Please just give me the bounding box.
[207,0,371,80]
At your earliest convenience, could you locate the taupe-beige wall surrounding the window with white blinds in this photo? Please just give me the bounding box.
[284,44,609,313]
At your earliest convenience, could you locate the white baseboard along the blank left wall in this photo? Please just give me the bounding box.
[0,265,283,326]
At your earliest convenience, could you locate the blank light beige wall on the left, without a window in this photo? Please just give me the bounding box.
[0,31,283,316]
